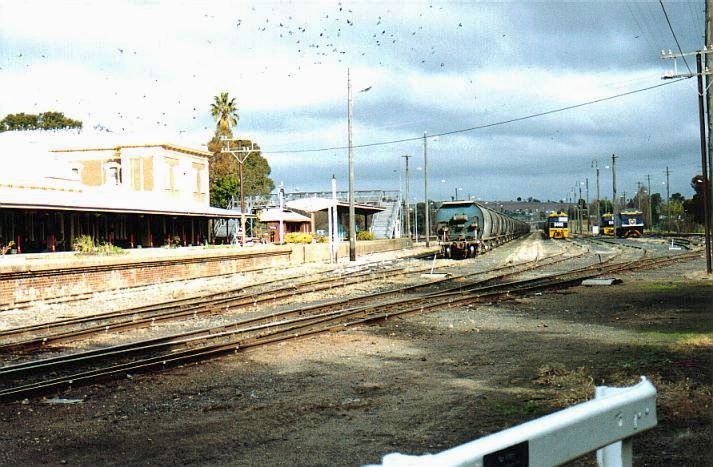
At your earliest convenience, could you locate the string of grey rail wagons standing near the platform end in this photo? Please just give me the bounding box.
[436,201,530,258]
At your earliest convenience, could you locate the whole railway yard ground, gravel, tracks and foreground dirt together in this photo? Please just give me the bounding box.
[0,236,713,465]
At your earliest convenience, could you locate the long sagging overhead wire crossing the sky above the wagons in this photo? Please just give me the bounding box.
[262,78,688,154]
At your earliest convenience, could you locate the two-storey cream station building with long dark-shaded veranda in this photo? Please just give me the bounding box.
[0,130,239,253]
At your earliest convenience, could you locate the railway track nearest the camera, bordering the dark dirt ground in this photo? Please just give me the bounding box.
[0,238,699,400]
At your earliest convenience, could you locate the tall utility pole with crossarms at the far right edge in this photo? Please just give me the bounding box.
[661,46,713,274]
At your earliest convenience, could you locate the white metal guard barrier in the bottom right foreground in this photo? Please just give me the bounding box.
[368,376,656,467]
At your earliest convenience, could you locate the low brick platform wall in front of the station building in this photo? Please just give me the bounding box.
[0,239,410,309]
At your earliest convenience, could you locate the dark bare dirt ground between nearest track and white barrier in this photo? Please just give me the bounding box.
[0,247,713,466]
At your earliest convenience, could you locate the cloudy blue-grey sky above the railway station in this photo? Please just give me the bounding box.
[0,0,704,200]
